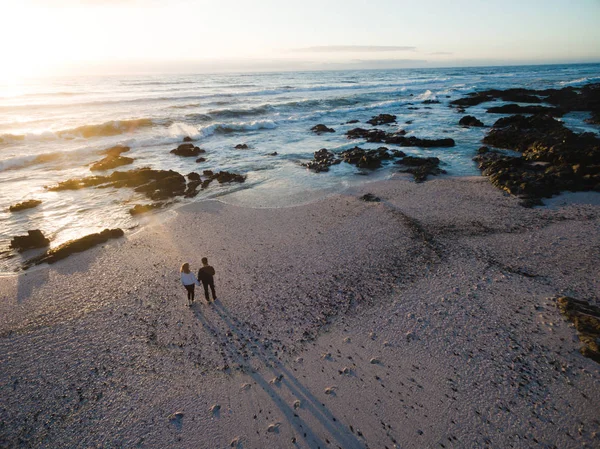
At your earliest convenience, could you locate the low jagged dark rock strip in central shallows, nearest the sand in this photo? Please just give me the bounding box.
[302,147,404,173]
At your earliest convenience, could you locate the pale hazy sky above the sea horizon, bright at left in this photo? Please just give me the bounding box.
[0,0,600,78]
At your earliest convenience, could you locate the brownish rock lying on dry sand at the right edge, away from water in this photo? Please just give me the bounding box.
[556,296,600,363]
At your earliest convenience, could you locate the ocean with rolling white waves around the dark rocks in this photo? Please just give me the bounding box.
[0,64,600,273]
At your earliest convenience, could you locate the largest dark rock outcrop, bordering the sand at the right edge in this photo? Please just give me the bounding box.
[473,115,600,200]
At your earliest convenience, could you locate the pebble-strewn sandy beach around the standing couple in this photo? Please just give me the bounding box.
[0,177,600,449]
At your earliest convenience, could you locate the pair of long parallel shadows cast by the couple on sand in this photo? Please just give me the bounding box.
[194,300,366,449]
